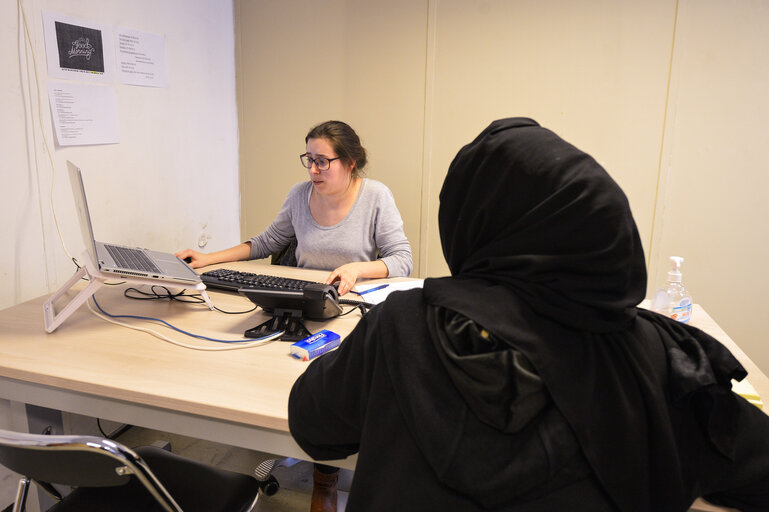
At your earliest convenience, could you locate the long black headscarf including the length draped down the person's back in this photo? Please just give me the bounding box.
[424,118,744,510]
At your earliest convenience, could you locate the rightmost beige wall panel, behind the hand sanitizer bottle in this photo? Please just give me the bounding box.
[651,0,769,374]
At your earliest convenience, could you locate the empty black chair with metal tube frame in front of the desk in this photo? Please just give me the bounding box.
[0,430,259,512]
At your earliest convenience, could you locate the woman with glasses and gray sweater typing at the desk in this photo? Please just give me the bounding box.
[177,121,413,295]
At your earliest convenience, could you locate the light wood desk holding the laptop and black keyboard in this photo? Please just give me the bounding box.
[0,270,769,468]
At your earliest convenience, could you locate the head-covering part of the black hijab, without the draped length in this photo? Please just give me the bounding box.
[438,118,646,331]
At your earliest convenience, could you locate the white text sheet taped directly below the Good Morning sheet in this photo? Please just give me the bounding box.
[48,82,120,146]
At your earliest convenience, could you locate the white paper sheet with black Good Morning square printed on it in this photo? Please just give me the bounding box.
[43,11,115,83]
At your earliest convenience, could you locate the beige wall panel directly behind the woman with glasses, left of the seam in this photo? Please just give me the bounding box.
[235,0,427,271]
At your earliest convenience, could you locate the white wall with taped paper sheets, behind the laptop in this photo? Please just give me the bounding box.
[0,0,240,314]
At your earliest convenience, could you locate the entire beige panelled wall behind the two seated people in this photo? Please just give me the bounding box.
[235,0,769,372]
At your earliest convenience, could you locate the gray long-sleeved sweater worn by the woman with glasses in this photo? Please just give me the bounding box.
[249,178,413,277]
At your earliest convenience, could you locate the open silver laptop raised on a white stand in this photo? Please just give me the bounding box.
[67,161,201,286]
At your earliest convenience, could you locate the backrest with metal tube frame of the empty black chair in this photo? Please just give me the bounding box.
[0,430,181,512]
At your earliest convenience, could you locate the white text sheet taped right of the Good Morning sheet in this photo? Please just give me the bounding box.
[115,27,168,87]
